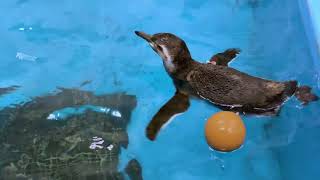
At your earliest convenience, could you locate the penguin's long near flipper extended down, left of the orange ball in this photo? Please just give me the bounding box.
[146,91,190,141]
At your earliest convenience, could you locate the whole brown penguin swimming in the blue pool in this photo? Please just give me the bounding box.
[135,31,318,141]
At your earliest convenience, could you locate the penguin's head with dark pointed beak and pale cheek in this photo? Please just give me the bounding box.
[135,31,191,72]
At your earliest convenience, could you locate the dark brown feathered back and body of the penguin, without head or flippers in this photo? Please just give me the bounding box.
[188,63,297,114]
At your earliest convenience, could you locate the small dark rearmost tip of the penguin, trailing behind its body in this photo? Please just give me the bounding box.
[295,86,319,105]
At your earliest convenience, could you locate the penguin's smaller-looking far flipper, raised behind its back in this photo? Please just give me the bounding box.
[209,48,241,66]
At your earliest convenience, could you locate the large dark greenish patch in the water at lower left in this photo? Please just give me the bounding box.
[0,89,141,179]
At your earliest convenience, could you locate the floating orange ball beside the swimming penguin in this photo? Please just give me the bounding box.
[205,111,246,152]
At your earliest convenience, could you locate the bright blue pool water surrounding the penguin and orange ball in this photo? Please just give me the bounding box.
[0,0,320,180]
